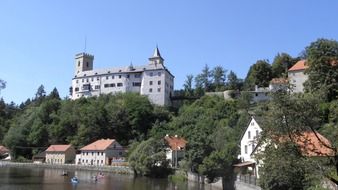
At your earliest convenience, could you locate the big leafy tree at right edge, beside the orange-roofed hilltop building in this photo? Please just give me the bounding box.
[305,39,338,101]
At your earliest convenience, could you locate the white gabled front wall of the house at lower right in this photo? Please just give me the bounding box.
[235,117,262,178]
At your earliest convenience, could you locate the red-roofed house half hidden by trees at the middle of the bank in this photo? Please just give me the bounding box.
[164,135,187,168]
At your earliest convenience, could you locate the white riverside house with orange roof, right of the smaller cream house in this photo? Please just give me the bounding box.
[76,139,125,166]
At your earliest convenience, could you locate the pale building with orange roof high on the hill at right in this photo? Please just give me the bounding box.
[288,59,308,93]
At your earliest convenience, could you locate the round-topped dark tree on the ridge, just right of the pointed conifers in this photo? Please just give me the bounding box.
[244,60,272,90]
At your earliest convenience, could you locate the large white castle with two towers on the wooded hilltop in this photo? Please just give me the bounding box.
[70,47,174,106]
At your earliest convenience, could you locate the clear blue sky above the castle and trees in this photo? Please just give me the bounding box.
[0,0,338,104]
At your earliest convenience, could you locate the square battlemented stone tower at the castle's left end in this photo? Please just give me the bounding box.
[75,53,94,75]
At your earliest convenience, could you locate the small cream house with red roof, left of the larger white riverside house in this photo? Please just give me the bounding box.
[46,145,75,164]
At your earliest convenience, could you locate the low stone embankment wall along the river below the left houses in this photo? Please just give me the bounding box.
[0,161,134,175]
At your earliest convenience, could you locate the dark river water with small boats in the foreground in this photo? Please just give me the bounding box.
[0,167,217,190]
